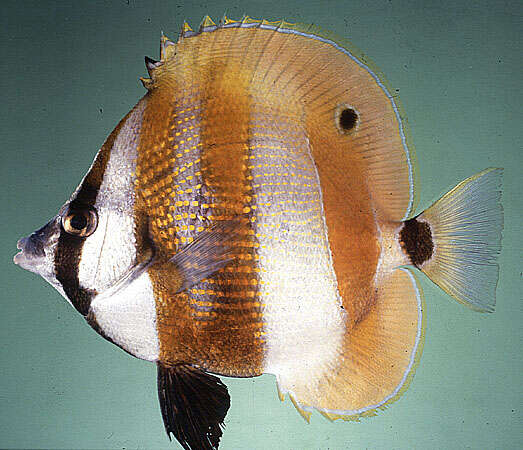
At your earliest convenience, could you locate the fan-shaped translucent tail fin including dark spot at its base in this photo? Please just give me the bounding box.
[400,168,503,312]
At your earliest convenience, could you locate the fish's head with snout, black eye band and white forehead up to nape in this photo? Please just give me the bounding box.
[14,100,151,316]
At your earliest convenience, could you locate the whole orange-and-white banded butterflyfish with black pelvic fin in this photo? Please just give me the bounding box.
[14,16,503,449]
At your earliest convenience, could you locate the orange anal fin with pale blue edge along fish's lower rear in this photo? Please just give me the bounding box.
[279,268,424,420]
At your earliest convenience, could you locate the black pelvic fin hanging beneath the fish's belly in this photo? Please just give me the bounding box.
[158,364,230,450]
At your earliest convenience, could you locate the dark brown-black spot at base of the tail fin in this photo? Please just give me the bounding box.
[399,217,434,267]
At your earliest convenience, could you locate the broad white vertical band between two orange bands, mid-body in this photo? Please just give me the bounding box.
[251,101,344,390]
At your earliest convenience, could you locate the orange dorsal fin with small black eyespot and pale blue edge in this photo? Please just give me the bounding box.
[150,18,416,221]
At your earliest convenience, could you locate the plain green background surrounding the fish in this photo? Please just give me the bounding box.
[0,0,523,450]
